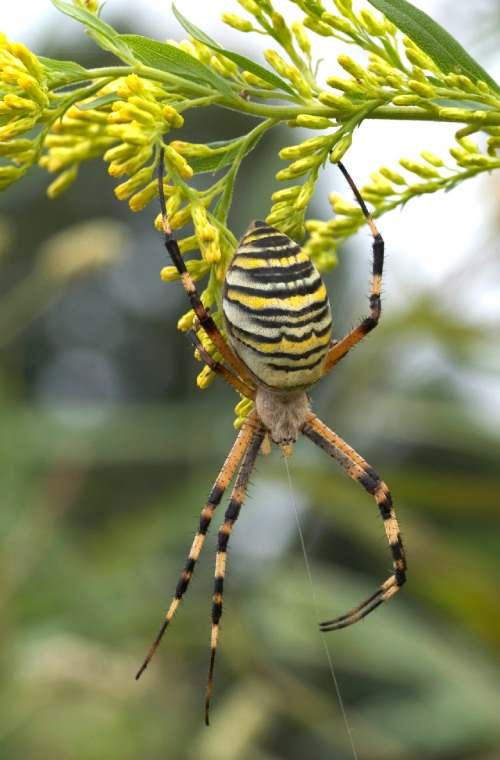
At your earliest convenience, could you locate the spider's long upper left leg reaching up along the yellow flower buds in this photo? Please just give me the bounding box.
[158,148,249,380]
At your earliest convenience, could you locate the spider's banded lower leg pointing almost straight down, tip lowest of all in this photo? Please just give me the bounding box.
[205,425,265,726]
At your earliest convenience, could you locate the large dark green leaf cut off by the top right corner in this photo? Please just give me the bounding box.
[369,0,500,92]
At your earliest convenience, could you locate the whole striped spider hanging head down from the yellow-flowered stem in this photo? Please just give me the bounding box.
[136,150,406,725]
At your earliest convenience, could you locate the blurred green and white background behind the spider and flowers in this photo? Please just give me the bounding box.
[0,1,500,760]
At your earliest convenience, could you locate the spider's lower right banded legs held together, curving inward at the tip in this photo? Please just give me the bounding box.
[301,414,406,633]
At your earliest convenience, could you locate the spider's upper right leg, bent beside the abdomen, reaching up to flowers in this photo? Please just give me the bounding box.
[323,161,384,374]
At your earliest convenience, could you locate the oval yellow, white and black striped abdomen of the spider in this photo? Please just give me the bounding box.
[223,222,332,391]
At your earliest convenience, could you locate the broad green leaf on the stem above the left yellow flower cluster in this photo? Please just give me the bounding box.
[117,34,234,96]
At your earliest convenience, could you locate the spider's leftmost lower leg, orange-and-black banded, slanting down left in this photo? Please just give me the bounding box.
[136,412,262,679]
